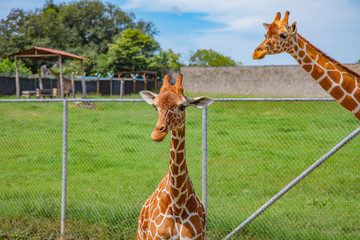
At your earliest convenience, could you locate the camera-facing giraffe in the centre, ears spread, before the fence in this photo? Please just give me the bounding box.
[137,75,214,240]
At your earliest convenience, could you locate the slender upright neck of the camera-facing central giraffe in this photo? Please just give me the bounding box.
[169,123,194,212]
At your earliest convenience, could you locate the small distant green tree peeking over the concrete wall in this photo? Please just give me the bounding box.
[189,49,241,67]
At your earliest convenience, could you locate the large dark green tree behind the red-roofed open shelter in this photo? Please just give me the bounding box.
[0,0,157,73]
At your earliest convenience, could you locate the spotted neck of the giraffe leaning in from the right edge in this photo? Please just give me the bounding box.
[287,34,360,120]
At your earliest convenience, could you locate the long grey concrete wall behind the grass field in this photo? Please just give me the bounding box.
[180,64,360,97]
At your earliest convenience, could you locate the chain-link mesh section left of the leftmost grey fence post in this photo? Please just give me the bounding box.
[0,102,62,239]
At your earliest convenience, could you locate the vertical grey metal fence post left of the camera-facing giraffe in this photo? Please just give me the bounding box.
[60,99,68,239]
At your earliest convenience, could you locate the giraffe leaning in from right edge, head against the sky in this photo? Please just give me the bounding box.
[252,11,360,120]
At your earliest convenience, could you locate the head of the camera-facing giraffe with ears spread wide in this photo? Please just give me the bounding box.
[140,74,214,142]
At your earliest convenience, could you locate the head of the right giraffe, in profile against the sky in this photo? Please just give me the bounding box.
[252,11,296,59]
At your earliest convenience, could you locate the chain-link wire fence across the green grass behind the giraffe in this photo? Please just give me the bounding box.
[0,99,360,239]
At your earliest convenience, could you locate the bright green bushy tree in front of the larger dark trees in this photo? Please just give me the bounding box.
[100,29,159,72]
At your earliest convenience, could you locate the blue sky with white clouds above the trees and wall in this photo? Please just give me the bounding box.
[0,0,360,66]
